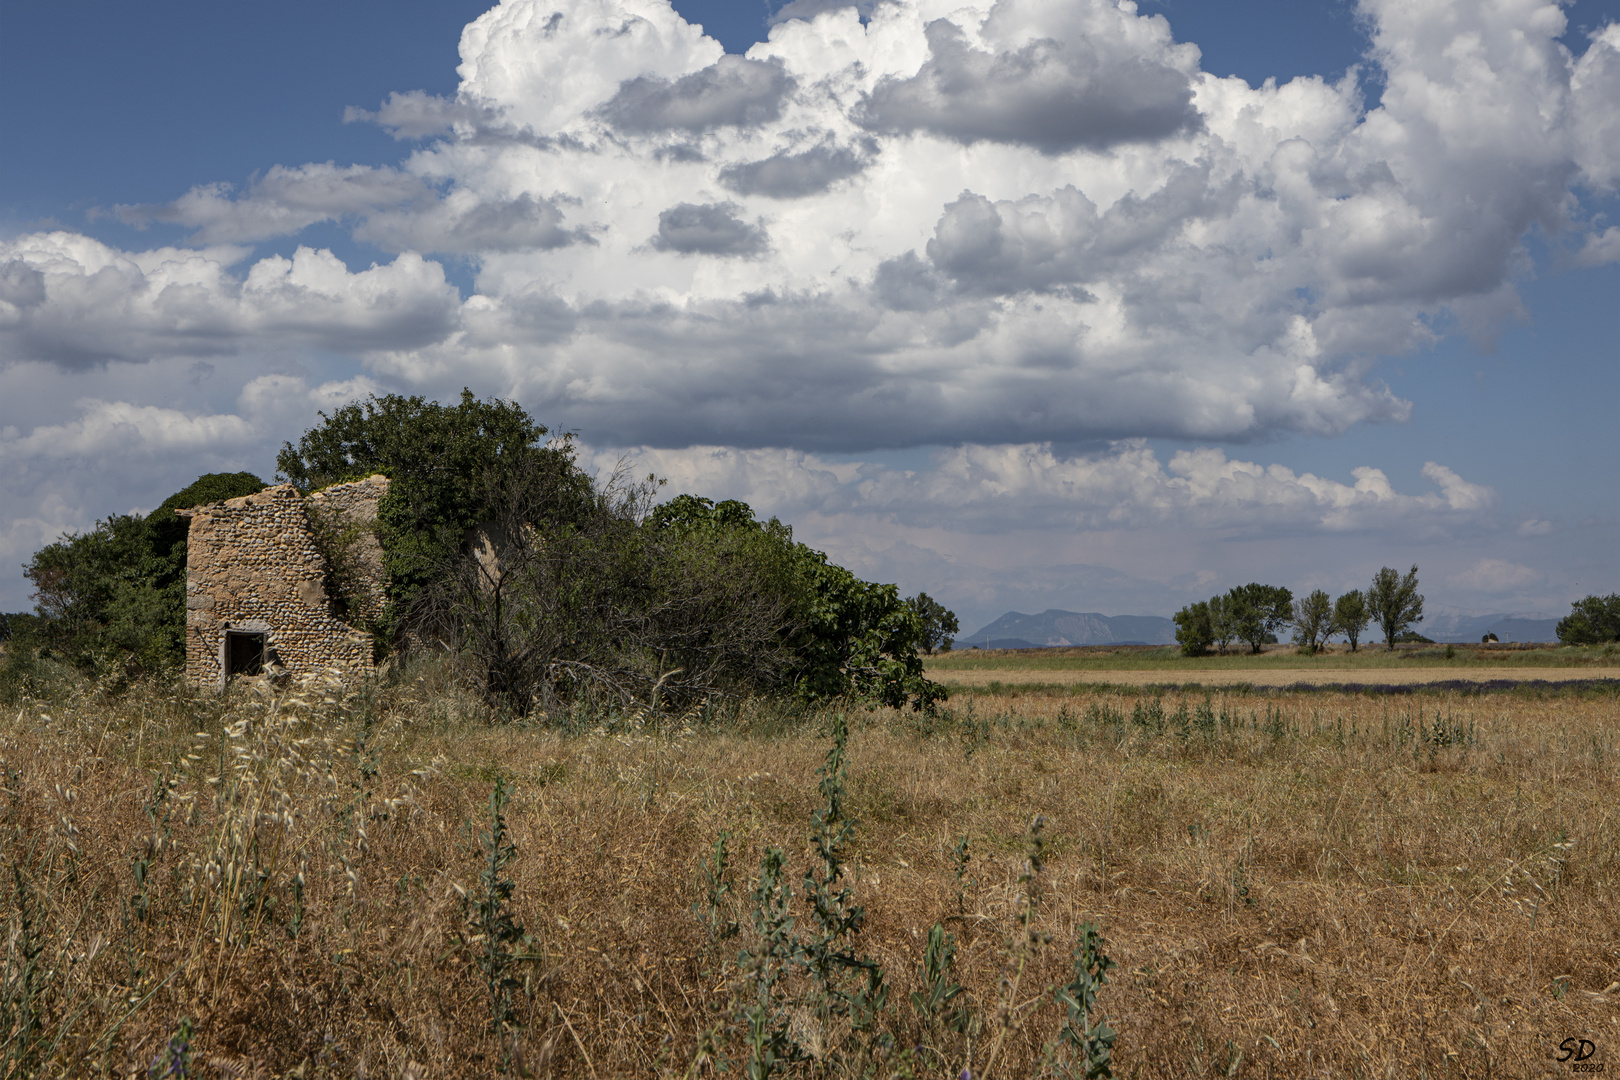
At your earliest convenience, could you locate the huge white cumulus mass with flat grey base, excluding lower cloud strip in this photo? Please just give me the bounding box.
[0,0,1620,450]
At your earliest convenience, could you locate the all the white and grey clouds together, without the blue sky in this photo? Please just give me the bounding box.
[0,0,1620,614]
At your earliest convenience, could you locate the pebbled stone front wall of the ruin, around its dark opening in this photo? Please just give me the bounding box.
[186,481,381,687]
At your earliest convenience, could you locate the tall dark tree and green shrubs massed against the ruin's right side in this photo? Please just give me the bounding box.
[277,390,943,714]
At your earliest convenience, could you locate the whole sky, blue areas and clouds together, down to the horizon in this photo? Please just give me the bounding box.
[0,0,1620,625]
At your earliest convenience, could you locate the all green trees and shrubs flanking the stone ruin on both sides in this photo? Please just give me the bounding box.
[6,392,957,714]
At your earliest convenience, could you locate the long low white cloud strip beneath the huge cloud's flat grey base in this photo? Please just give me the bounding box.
[591,440,1495,534]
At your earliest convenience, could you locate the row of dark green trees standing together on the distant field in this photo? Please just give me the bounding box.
[1175,567,1422,656]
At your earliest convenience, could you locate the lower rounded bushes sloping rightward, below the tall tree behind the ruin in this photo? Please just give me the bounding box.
[411,459,943,716]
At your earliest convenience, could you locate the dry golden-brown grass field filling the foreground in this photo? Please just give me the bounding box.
[0,667,1620,1078]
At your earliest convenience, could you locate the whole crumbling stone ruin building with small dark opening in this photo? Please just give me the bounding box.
[180,476,389,688]
